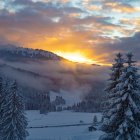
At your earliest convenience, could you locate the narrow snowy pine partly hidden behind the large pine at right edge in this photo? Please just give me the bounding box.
[101,53,124,132]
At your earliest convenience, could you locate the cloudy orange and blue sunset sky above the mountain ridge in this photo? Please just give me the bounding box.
[0,0,140,65]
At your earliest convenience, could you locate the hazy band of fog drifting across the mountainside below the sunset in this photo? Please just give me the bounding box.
[1,60,109,97]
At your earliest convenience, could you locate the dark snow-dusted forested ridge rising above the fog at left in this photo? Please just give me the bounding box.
[0,45,62,61]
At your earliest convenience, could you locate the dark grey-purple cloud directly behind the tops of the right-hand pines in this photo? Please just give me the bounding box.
[92,32,140,64]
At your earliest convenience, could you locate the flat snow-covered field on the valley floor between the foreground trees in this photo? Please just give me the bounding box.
[27,111,103,140]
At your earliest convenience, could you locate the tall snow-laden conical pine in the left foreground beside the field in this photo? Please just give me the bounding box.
[0,81,28,140]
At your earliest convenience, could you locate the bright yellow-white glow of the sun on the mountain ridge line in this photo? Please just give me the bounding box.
[55,52,95,64]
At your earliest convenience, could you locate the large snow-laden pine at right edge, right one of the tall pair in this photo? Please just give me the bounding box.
[100,53,140,140]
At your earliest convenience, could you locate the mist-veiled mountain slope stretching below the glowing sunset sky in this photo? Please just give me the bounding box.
[0,45,106,109]
